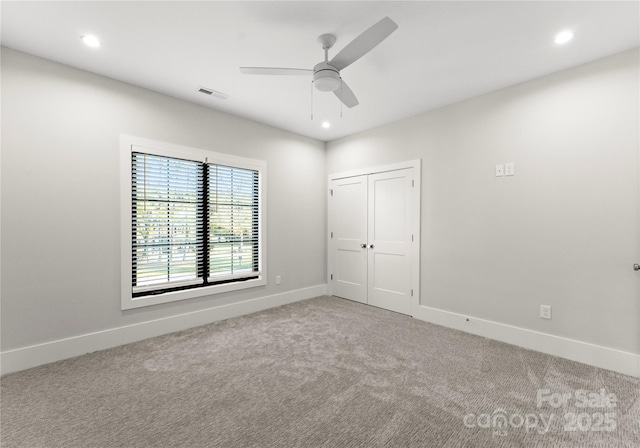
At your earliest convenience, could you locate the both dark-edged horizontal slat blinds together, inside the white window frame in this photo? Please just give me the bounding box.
[131,152,260,297]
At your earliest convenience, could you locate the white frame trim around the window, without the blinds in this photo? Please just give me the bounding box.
[120,135,267,310]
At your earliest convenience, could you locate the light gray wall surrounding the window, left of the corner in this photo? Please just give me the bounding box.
[1,48,326,351]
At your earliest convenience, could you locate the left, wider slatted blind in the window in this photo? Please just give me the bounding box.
[131,152,204,292]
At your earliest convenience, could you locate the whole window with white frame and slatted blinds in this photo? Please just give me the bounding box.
[121,137,266,309]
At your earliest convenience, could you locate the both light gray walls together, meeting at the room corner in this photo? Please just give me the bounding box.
[1,45,640,353]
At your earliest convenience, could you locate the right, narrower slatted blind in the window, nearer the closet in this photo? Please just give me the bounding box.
[208,164,260,282]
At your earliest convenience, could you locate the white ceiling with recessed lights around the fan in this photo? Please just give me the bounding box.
[1,1,640,141]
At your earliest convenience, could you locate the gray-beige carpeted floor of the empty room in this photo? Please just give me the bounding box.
[1,297,640,448]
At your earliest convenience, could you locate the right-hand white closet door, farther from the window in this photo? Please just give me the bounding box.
[367,168,413,314]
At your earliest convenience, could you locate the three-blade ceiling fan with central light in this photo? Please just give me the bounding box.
[240,17,398,108]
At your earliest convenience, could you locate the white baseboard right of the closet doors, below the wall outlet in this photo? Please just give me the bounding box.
[413,305,640,378]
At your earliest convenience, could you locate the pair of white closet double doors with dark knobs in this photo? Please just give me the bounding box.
[330,168,413,314]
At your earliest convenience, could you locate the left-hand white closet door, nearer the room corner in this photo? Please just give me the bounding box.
[329,175,367,303]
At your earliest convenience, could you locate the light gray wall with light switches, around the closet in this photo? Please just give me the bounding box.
[327,49,640,353]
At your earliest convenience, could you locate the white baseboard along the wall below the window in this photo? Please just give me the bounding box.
[0,285,327,375]
